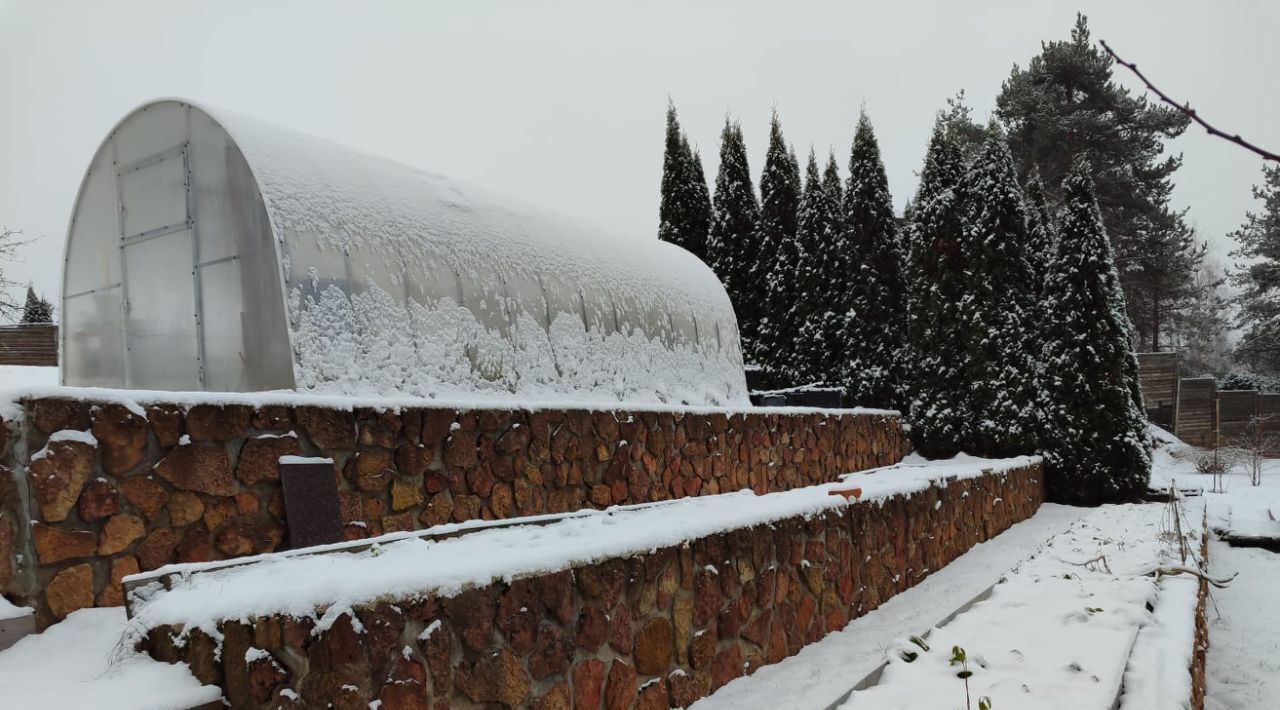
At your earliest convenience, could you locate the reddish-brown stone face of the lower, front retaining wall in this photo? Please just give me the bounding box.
[146,464,1044,710]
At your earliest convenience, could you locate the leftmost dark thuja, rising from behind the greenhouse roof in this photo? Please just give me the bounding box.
[658,104,710,261]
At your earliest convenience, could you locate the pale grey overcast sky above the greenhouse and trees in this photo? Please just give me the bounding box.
[0,0,1280,317]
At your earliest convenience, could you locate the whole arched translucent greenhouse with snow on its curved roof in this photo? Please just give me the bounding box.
[61,101,746,404]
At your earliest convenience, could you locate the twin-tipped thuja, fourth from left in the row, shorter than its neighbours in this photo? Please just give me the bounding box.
[788,150,850,385]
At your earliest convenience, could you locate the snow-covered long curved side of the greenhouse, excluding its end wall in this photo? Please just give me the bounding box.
[211,104,746,406]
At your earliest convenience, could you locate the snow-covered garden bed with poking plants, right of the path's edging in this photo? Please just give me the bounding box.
[841,505,1198,710]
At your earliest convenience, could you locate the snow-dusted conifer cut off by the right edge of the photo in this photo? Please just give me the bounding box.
[1231,166,1280,374]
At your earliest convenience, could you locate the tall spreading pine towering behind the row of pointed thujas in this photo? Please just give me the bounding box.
[996,14,1198,348]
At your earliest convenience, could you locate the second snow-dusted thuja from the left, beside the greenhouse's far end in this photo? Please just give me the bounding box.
[707,120,765,359]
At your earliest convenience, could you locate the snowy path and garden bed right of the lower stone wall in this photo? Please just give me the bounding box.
[694,505,1199,710]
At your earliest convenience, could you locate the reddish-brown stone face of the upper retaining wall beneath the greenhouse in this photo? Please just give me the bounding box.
[0,395,909,626]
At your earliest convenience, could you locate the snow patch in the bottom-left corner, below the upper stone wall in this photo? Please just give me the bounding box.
[0,608,221,710]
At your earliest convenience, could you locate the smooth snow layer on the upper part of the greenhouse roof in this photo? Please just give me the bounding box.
[206,109,732,321]
